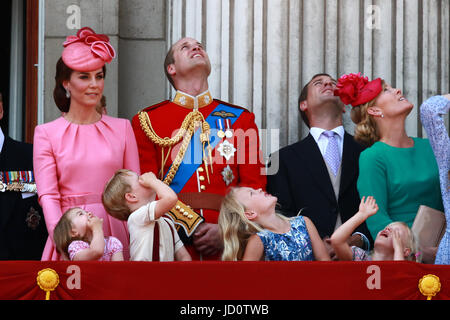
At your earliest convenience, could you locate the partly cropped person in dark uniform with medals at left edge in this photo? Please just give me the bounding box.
[0,93,48,260]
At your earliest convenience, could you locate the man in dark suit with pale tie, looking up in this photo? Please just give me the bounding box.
[267,74,373,255]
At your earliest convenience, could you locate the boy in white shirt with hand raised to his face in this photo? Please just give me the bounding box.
[102,169,191,261]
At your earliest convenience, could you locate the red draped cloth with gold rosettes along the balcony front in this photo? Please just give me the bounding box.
[0,261,450,300]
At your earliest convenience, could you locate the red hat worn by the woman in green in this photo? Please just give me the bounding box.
[334,72,383,107]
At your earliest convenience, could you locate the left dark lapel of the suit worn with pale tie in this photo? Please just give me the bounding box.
[295,134,336,201]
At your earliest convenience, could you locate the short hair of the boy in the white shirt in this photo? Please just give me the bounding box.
[102,169,132,221]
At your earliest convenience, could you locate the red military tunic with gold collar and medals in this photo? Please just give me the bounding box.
[132,91,266,258]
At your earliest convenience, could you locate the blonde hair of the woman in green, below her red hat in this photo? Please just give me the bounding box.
[350,80,386,147]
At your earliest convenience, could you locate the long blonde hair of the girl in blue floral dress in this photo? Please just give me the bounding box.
[218,187,290,261]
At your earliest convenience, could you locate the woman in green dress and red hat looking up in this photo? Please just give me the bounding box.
[335,74,443,262]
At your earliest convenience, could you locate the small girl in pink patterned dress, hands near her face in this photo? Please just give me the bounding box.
[53,208,123,261]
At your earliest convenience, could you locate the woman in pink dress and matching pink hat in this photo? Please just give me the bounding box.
[33,27,140,260]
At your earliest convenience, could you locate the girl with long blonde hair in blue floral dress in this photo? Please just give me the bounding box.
[219,187,330,261]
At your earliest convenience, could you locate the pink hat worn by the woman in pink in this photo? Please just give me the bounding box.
[62,27,116,72]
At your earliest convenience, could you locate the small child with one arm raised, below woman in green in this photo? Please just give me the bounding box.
[331,196,417,261]
